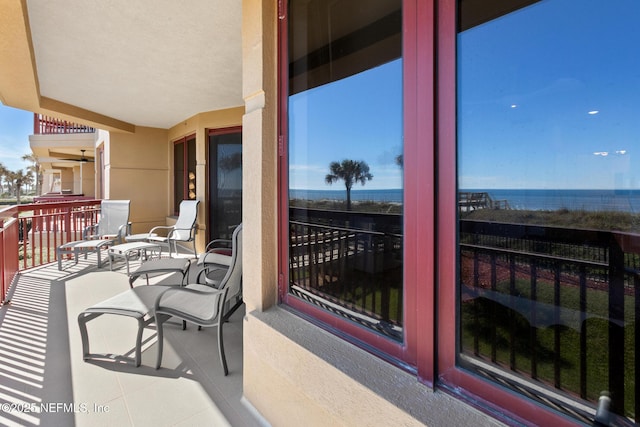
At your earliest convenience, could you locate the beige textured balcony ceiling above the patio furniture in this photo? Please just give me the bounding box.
[0,0,243,130]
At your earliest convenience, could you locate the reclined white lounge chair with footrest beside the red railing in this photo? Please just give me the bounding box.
[56,200,131,270]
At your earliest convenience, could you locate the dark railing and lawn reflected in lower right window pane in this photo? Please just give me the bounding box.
[459,220,640,419]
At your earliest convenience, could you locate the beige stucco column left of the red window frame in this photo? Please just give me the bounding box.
[242,0,278,312]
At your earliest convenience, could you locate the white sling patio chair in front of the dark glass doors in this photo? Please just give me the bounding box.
[139,200,200,257]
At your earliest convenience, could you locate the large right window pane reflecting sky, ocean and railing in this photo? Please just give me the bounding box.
[457,0,640,422]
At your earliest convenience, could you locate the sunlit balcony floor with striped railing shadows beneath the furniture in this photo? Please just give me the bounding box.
[0,255,264,427]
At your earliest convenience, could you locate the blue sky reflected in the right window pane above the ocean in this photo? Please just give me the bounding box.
[458,0,640,189]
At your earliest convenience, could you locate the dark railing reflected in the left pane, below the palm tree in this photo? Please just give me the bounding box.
[289,208,402,340]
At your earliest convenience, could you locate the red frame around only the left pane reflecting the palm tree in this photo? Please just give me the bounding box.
[278,0,434,378]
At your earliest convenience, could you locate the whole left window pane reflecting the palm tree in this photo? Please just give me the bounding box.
[288,0,403,341]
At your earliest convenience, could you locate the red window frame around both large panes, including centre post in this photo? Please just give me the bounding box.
[277,0,575,425]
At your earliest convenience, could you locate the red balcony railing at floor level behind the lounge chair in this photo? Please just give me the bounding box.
[0,199,101,301]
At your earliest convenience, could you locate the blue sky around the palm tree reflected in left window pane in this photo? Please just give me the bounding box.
[289,60,402,191]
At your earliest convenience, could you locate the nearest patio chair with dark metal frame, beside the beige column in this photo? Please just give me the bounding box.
[153,225,242,375]
